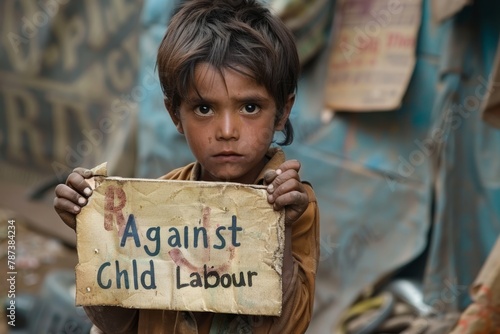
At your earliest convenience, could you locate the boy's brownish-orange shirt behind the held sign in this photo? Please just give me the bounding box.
[138,148,319,334]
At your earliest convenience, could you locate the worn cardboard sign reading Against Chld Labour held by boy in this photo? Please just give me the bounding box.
[76,170,284,316]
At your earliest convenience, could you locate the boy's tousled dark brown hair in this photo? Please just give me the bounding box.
[157,0,300,145]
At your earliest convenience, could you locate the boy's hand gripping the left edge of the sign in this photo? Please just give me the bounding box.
[54,168,93,230]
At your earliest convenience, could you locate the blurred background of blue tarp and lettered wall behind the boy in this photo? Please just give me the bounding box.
[0,0,500,333]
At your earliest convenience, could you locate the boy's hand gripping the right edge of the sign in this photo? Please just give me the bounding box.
[264,160,309,225]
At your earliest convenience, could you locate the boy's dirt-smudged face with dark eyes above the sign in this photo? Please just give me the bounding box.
[169,63,294,184]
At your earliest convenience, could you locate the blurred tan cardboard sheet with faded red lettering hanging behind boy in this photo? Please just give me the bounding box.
[325,0,422,111]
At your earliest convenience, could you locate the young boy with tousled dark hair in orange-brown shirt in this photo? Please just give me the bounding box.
[54,0,319,333]
